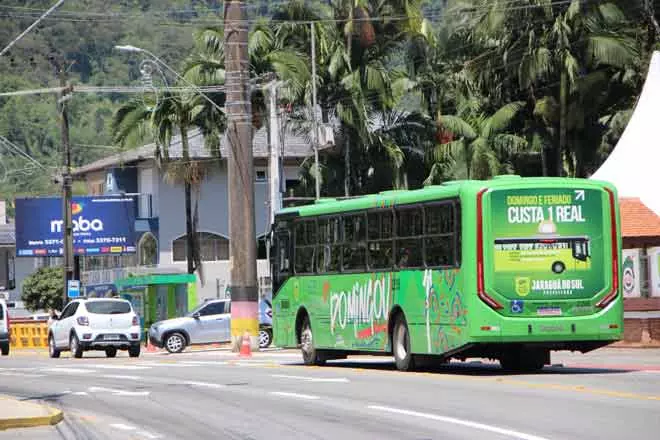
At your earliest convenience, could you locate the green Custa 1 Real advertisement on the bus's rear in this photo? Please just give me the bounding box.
[486,188,609,300]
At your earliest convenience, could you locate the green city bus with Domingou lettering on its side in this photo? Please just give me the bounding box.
[271,176,623,371]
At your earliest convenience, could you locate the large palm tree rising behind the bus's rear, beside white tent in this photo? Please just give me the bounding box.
[452,0,637,174]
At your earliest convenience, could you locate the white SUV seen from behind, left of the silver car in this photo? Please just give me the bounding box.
[48,298,141,358]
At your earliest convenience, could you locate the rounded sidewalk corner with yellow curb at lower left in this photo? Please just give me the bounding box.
[0,395,64,431]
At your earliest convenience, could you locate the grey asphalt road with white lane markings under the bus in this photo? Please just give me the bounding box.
[0,349,660,440]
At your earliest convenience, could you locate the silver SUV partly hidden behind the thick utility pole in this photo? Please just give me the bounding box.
[149,299,273,353]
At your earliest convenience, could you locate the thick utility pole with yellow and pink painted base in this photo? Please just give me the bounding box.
[224,0,259,351]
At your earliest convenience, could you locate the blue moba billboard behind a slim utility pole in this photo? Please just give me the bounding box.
[16,196,135,257]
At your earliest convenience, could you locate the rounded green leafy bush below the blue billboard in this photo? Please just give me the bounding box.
[21,267,64,311]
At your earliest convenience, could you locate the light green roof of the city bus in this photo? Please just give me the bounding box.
[277,175,616,217]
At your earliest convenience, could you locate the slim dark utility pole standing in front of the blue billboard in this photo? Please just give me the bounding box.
[54,61,75,306]
